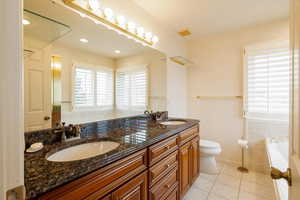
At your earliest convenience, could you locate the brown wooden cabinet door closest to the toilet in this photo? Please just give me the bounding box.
[189,137,199,184]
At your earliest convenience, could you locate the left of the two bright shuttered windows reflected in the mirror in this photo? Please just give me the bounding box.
[73,66,114,109]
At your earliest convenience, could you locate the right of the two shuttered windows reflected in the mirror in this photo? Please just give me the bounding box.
[116,67,148,110]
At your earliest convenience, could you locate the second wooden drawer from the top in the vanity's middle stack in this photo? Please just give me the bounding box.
[149,151,178,187]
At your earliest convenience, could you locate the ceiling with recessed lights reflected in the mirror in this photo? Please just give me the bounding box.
[24,0,152,58]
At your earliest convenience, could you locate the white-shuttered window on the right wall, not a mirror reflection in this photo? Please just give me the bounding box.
[245,44,290,120]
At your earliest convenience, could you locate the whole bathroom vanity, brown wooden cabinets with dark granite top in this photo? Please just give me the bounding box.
[25,117,200,200]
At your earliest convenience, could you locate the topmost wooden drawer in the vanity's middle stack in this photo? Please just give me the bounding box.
[149,135,178,166]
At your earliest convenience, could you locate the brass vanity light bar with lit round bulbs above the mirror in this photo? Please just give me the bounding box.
[62,0,159,46]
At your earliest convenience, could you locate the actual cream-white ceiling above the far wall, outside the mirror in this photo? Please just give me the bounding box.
[133,0,289,38]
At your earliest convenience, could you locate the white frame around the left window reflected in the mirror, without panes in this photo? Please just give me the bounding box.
[71,61,115,112]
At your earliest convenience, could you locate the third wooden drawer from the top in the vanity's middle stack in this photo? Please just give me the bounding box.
[149,167,178,200]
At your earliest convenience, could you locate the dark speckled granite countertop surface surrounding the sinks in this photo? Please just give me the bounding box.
[24,119,199,199]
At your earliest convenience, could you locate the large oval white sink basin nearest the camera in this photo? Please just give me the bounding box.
[47,141,120,162]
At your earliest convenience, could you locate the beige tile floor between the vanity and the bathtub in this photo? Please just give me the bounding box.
[184,164,276,200]
